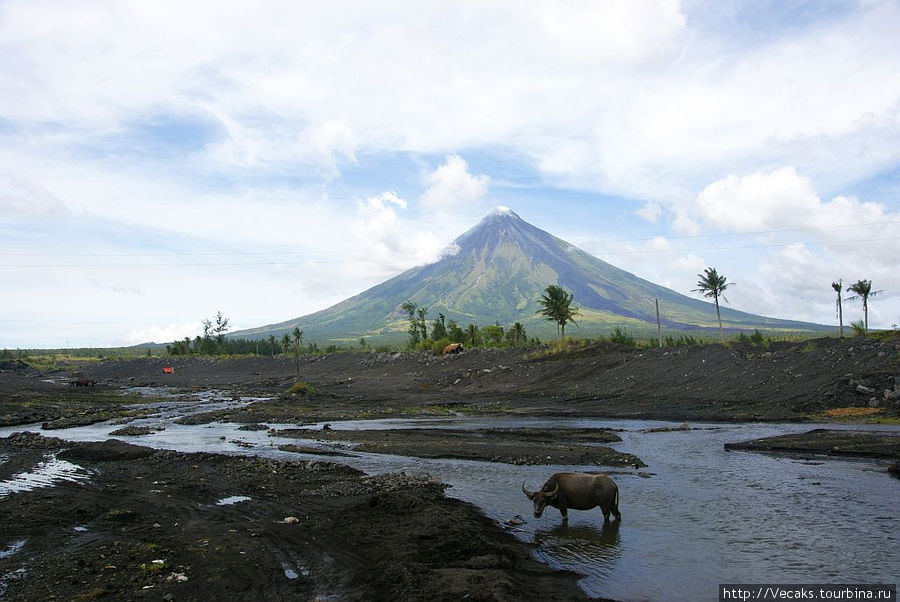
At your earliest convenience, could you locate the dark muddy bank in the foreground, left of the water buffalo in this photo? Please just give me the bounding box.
[0,434,585,600]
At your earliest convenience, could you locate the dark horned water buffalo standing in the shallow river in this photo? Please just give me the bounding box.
[522,472,622,522]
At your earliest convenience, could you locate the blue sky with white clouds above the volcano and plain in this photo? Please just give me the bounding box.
[0,0,900,349]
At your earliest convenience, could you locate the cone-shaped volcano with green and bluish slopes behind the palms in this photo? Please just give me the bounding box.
[231,207,827,343]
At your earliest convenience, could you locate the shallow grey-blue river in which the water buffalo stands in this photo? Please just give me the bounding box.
[0,395,900,600]
